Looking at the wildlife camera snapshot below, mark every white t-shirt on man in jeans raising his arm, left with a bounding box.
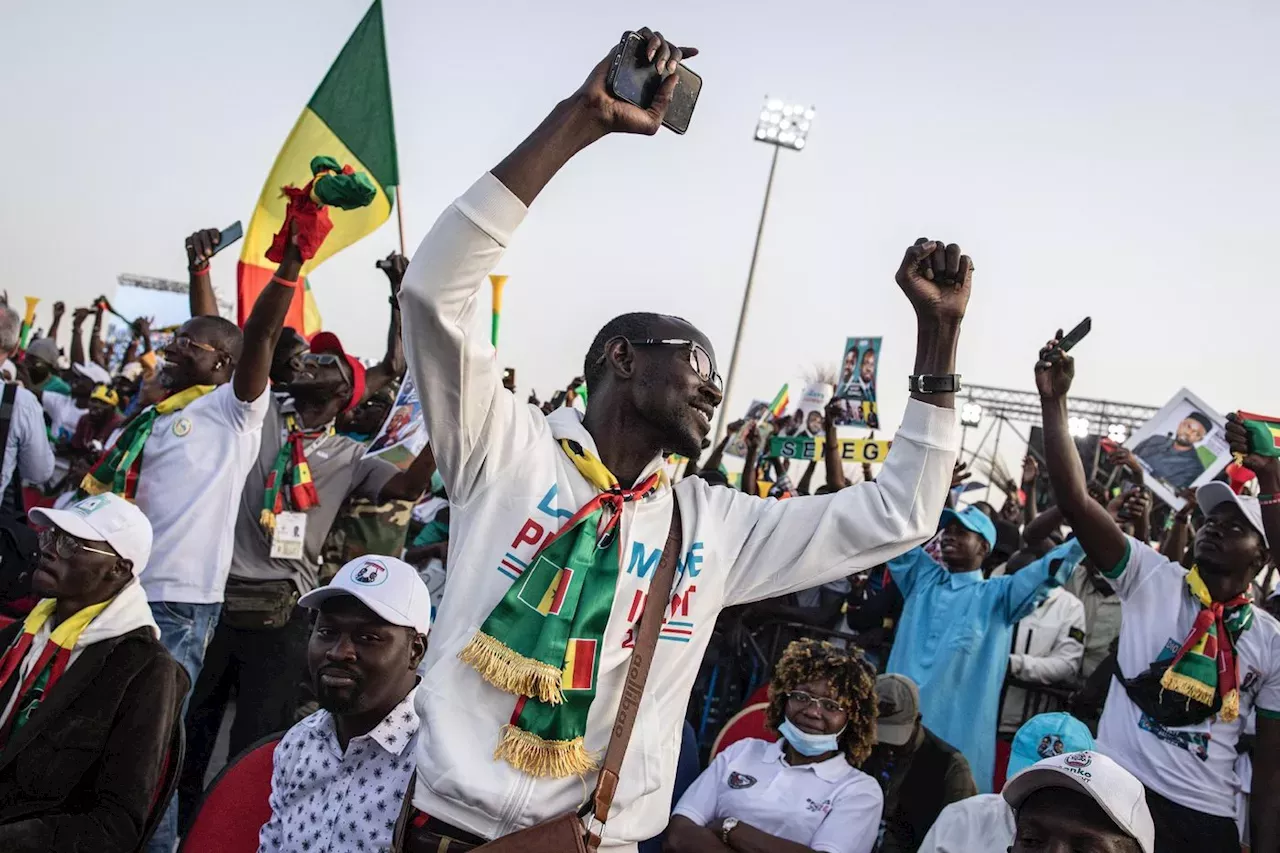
[137,383,271,605]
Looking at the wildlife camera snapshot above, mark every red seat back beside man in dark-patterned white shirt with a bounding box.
[178,733,284,853]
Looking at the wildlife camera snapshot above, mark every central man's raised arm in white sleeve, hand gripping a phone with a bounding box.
[399,33,696,502]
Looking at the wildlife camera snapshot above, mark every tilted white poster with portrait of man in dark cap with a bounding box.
[1125,388,1231,510]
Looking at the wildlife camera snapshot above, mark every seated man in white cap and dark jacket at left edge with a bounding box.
[0,494,187,853]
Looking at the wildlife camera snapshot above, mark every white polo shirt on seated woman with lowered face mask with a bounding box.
[672,738,884,853]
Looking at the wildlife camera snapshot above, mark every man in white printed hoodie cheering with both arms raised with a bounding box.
[399,29,972,849]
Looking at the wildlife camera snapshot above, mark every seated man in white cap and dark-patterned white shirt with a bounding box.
[259,555,431,853]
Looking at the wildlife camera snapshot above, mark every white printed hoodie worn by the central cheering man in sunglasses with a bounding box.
[399,174,959,850]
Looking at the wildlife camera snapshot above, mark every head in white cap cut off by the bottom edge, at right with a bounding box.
[1004,751,1156,853]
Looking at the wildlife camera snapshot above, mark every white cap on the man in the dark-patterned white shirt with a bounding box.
[298,553,431,637]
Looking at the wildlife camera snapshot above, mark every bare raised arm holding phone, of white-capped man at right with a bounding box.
[1024,330,1129,573]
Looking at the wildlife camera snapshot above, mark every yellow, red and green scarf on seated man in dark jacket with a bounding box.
[0,598,111,748]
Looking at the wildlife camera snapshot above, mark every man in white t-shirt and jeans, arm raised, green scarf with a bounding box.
[81,224,302,853]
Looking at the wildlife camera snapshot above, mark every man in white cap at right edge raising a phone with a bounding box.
[1036,341,1280,853]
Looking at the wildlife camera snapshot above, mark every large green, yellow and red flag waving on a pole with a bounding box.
[237,0,399,338]
